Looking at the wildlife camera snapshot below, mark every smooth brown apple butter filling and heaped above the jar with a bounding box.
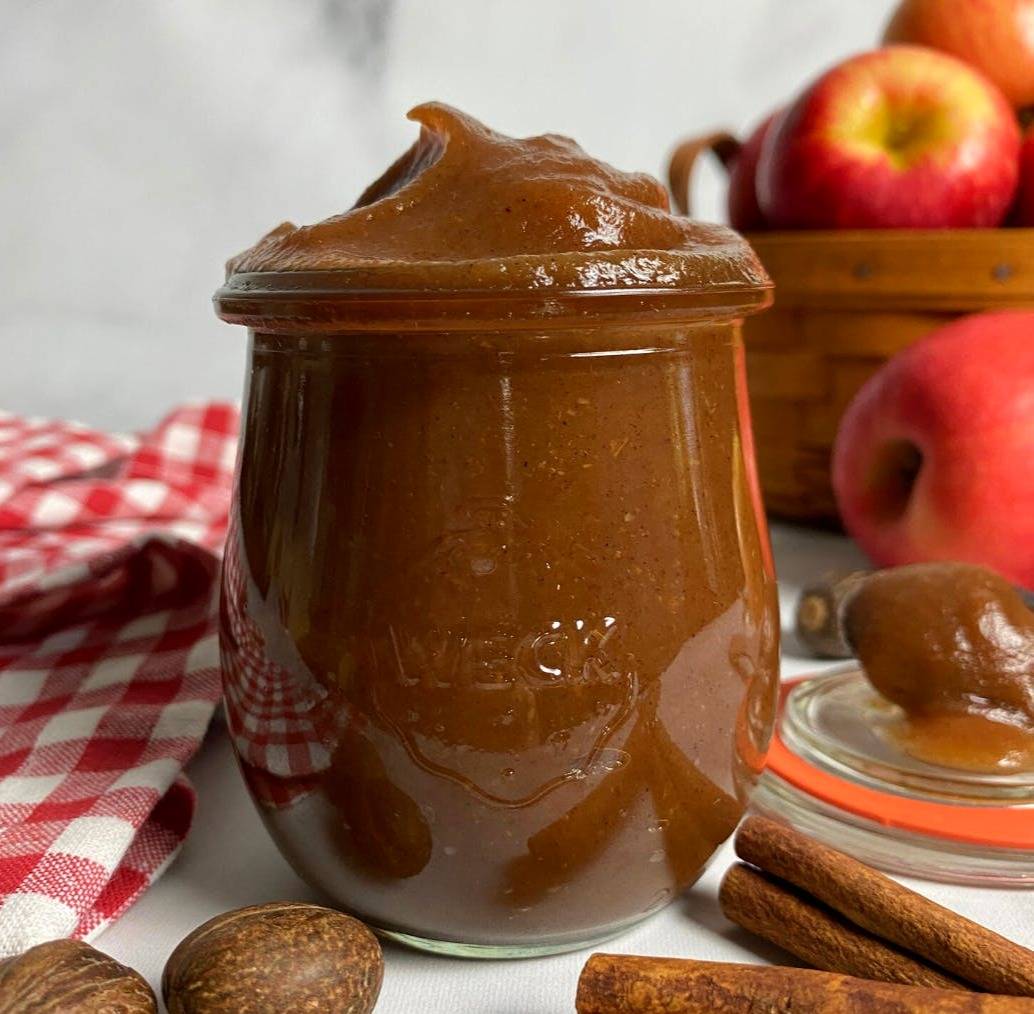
[222,98,778,945]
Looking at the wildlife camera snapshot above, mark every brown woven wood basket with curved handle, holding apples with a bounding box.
[670,134,1034,527]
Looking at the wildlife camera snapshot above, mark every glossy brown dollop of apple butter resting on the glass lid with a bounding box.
[846,563,1034,771]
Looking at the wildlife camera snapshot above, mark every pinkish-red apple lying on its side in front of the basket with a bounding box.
[832,310,1034,588]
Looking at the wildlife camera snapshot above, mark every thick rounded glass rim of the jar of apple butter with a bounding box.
[212,270,773,333]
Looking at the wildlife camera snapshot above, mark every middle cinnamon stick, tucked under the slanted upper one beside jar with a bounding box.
[718,863,968,990]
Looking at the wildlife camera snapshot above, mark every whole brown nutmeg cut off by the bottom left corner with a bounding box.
[0,940,158,1014]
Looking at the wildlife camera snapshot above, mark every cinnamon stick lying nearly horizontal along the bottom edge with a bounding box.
[575,954,1034,1014]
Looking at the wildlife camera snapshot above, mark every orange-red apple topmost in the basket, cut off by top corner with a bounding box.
[883,0,1034,106]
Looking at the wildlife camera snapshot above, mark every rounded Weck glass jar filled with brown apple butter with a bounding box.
[216,272,779,956]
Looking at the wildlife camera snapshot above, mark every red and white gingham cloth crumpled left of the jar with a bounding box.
[0,404,238,957]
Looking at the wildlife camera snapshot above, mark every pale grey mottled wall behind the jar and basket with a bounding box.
[0,0,893,428]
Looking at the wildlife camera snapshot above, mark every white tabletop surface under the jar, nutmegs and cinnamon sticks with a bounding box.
[96,526,1034,1014]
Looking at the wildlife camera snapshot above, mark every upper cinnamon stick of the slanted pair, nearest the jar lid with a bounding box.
[736,817,1034,996]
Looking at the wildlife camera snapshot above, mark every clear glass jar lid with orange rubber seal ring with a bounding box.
[754,678,1034,886]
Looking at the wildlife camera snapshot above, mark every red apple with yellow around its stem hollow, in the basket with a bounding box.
[758,45,1020,228]
